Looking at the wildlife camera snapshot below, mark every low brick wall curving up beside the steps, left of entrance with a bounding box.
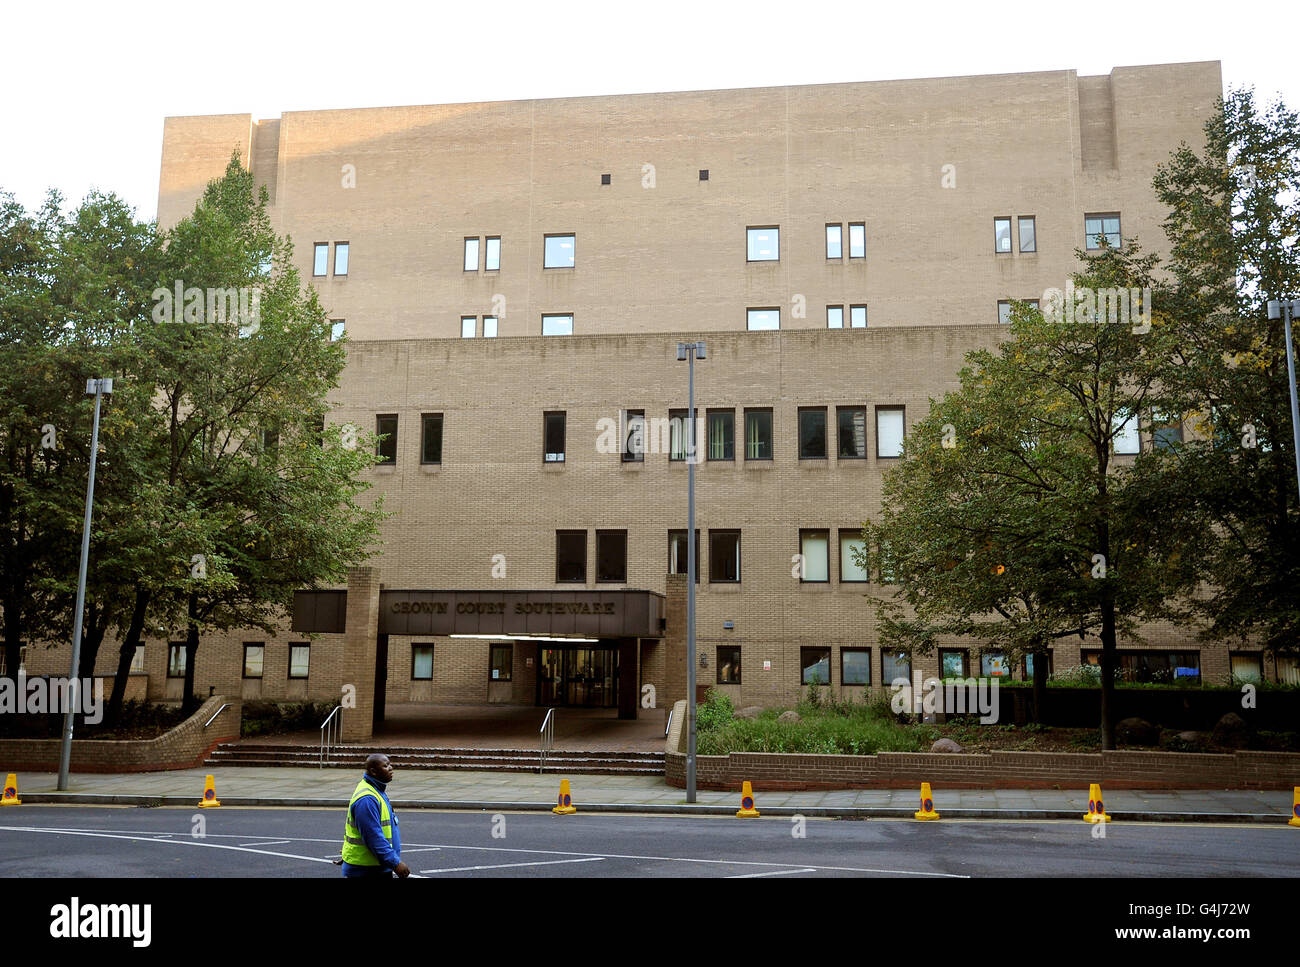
[0,695,243,772]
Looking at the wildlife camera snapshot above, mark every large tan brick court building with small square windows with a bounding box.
[42,62,1296,738]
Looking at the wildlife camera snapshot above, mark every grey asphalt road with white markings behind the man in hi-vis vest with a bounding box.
[0,806,1300,880]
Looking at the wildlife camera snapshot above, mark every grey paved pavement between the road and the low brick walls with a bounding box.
[4,766,1300,834]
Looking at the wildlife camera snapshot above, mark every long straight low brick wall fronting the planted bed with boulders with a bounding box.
[666,750,1300,792]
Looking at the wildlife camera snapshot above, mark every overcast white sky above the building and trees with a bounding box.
[0,0,1300,218]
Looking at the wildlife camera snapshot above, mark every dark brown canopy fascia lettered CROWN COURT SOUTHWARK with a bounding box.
[293,590,664,638]
